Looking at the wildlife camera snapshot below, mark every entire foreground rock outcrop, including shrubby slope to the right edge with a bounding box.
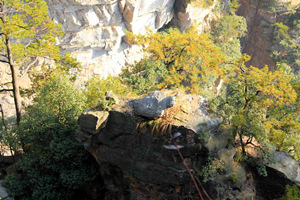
[78,91,300,200]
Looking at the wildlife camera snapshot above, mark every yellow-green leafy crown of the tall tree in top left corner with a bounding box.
[0,0,63,66]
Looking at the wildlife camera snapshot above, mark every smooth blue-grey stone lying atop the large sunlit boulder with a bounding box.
[133,91,175,119]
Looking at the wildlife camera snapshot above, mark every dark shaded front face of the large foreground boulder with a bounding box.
[79,111,213,200]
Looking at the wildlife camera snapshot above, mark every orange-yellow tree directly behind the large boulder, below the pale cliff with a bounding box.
[127,28,226,93]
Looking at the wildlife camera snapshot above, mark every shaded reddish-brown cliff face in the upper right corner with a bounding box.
[237,0,300,70]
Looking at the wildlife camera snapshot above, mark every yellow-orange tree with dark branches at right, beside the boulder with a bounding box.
[210,56,300,173]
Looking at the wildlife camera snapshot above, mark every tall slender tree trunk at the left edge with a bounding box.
[5,35,22,125]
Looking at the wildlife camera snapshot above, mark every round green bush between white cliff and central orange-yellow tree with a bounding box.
[122,60,169,94]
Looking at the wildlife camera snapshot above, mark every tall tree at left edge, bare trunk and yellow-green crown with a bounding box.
[0,0,62,124]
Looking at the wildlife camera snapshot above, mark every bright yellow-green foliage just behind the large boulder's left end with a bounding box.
[84,76,130,109]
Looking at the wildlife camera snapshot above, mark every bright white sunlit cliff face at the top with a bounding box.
[47,0,213,77]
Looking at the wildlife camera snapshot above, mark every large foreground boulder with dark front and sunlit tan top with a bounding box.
[78,91,244,200]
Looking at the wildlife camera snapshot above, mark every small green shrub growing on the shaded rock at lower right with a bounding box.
[201,158,225,183]
